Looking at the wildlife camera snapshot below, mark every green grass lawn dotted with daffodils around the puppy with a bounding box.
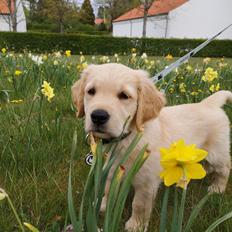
[0,51,232,232]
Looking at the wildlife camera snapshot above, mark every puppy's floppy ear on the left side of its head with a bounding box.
[71,65,92,118]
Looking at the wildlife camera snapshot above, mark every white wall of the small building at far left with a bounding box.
[0,0,27,32]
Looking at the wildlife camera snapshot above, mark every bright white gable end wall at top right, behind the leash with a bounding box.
[167,0,232,39]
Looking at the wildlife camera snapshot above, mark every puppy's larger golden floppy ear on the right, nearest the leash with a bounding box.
[135,70,166,130]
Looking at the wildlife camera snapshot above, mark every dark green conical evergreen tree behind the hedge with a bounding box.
[80,0,95,25]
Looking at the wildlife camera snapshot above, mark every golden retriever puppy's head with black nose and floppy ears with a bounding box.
[72,64,165,138]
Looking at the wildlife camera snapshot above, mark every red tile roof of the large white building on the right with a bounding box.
[114,0,188,22]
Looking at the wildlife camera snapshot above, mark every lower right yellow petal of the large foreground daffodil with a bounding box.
[185,163,206,179]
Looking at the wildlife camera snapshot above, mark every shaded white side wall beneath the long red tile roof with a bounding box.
[113,16,166,38]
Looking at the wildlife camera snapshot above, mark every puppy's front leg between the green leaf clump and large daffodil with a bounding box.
[125,178,160,232]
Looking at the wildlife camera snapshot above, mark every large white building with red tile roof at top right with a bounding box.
[113,0,232,39]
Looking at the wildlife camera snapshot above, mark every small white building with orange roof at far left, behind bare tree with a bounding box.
[0,0,27,32]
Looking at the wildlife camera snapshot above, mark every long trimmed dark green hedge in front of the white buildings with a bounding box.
[0,32,232,57]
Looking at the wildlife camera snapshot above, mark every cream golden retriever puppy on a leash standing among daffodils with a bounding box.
[72,64,232,231]
